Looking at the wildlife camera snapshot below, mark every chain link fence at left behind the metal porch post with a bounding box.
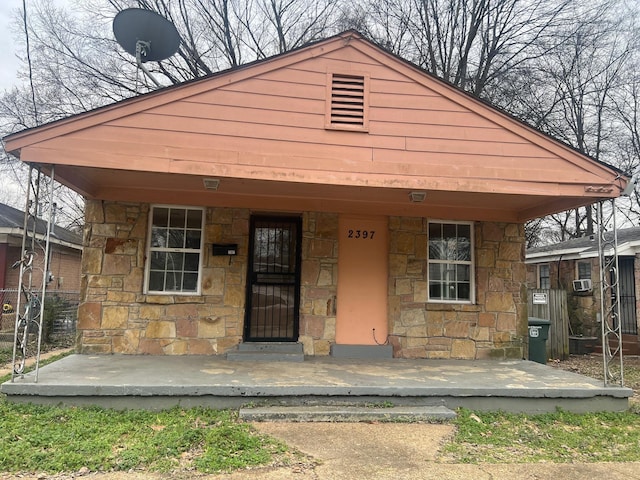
[0,290,80,351]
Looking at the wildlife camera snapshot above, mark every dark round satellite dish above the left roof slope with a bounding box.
[113,8,180,87]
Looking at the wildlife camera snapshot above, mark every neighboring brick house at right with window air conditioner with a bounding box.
[526,227,640,343]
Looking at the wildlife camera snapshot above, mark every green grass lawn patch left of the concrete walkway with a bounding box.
[0,401,292,473]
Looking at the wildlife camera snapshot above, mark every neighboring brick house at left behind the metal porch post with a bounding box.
[0,203,82,291]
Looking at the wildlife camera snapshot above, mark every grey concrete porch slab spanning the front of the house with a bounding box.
[0,355,633,413]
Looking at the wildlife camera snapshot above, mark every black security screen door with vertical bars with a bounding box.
[244,217,301,342]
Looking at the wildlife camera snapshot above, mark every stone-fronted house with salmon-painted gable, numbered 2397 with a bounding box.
[5,32,628,359]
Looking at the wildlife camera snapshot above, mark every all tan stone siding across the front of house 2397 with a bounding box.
[77,200,527,359]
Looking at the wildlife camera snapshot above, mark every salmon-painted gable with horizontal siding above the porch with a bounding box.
[5,32,628,221]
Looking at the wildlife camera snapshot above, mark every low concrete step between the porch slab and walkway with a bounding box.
[239,405,456,422]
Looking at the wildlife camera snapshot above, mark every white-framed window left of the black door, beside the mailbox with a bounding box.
[145,205,204,294]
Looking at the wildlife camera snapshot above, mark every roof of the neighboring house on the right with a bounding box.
[526,227,640,263]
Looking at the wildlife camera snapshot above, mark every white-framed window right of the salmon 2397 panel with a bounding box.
[427,222,475,303]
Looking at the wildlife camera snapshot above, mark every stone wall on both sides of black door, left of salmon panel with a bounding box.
[77,200,338,355]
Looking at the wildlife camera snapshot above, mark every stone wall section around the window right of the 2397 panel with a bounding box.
[389,217,527,359]
